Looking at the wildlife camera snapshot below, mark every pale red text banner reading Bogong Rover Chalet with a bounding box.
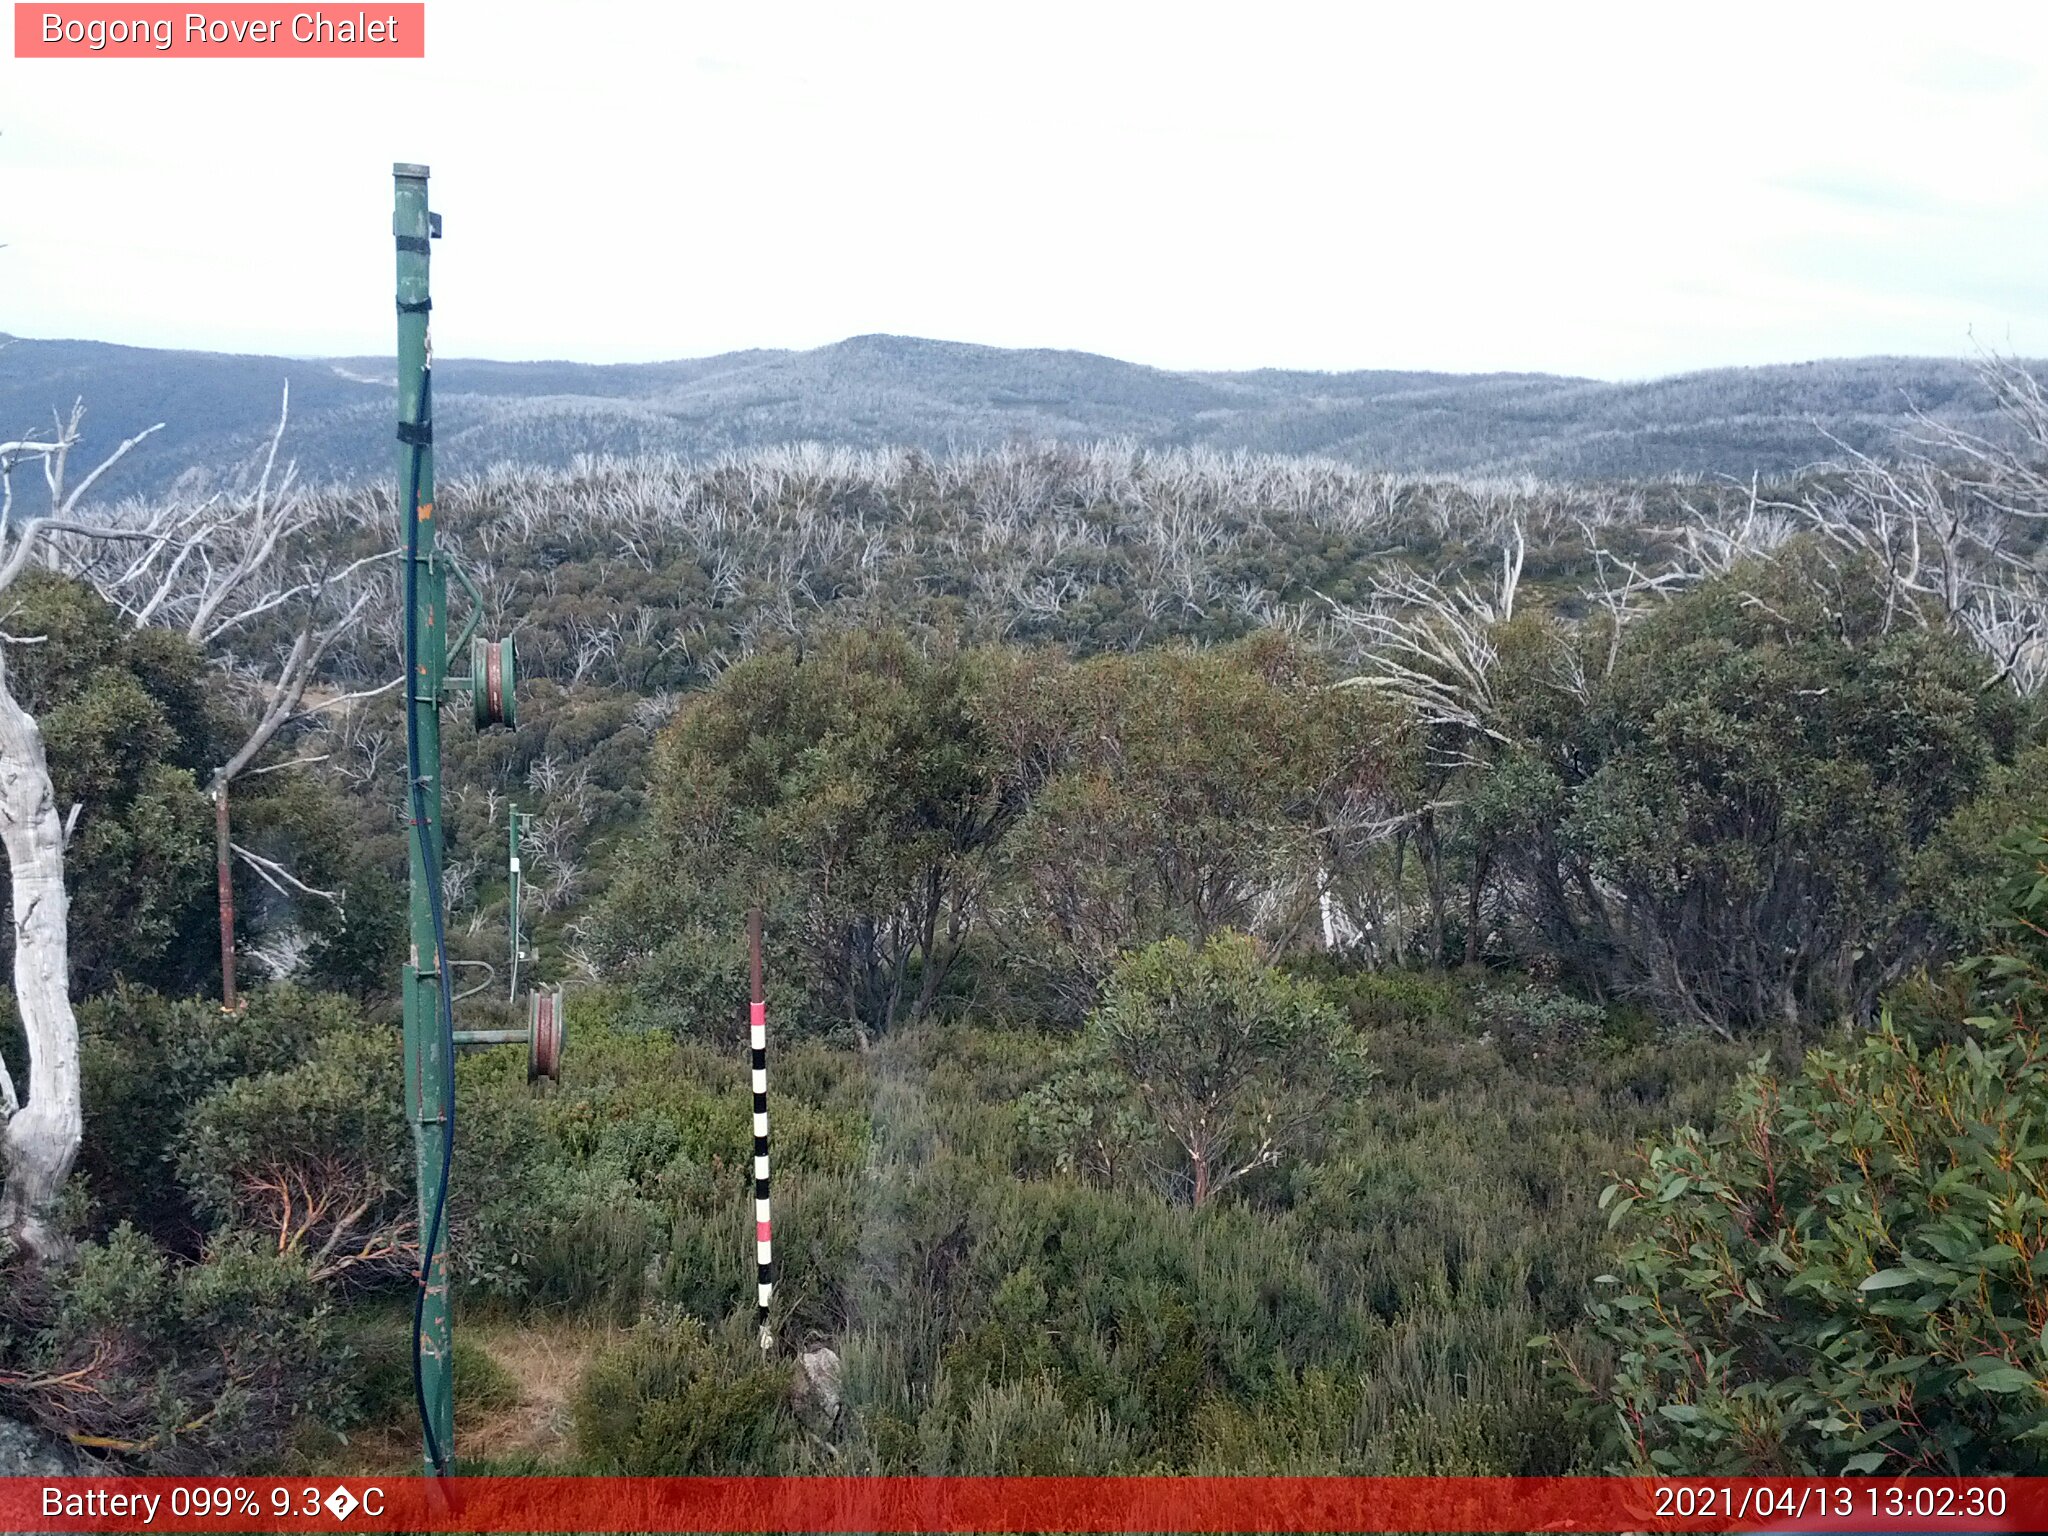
[14,0,426,59]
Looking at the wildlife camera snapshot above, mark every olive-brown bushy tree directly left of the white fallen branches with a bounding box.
[1001,629,1407,1022]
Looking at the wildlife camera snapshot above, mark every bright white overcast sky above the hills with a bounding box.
[0,0,2048,379]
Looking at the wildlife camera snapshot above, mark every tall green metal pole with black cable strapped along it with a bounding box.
[391,164,455,1473]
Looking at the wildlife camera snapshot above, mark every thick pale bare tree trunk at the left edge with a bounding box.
[0,657,84,1257]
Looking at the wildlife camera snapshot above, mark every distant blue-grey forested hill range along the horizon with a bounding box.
[0,336,2015,492]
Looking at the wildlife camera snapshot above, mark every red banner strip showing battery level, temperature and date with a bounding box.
[0,1477,2048,1532]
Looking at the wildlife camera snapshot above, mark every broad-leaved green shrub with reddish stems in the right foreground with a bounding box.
[1567,842,2048,1475]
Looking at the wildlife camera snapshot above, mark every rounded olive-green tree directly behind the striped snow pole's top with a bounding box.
[592,629,1051,1038]
